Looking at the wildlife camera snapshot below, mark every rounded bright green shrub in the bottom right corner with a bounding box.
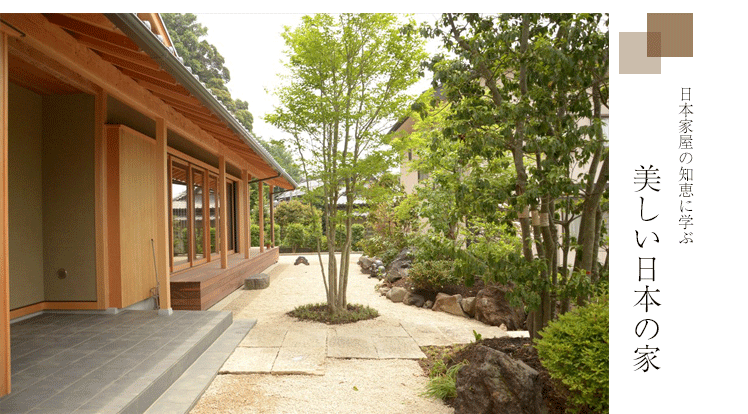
[535,296,609,413]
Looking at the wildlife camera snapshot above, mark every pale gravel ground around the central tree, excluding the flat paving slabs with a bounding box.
[191,255,496,414]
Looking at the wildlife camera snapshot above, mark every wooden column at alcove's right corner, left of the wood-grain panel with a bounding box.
[94,90,109,309]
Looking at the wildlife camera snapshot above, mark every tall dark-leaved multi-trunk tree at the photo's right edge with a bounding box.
[422,14,609,335]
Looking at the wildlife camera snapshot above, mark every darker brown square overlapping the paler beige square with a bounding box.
[647,13,693,57]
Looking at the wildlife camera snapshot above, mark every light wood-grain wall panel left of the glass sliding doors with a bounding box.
[119,126,159,307]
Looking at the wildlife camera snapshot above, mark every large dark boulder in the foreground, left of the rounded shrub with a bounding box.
[454,345,543,414]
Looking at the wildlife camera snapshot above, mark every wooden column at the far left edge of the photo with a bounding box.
[0,32,10,395]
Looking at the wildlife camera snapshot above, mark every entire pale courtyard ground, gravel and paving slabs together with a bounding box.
[192,255,527,414]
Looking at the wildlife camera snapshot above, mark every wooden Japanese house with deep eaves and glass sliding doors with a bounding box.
[0,13,296,396]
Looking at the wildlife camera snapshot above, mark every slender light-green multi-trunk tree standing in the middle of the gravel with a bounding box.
[267,14,425,312]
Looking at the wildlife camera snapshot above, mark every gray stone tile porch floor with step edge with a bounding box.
[0,310,231,413]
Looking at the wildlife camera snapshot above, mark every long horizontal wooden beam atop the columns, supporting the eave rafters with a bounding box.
[3,14,251,183]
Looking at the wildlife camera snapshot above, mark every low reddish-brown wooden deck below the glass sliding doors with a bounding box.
[171,247,278,310]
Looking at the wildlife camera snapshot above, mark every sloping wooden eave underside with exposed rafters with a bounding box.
[2,13,293,189]
